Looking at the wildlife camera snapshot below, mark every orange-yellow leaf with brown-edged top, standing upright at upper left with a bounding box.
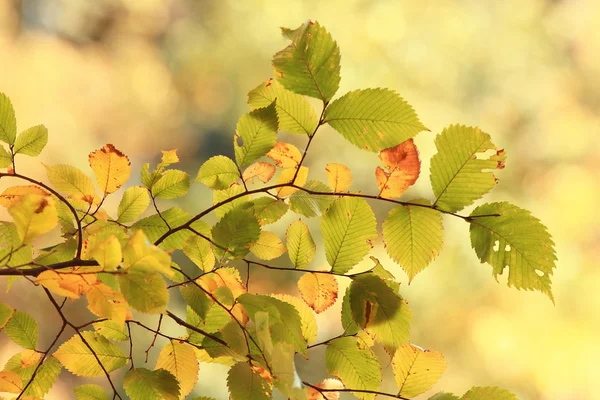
[88,144,131,195]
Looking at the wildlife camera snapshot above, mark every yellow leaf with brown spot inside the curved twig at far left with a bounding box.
[8,194,58,243]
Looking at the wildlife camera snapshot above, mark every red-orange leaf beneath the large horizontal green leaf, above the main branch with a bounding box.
[375,139,421,199]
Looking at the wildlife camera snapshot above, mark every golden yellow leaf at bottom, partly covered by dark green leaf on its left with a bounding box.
[154,340,199,399]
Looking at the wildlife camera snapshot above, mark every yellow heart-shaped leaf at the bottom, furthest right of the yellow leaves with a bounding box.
[392,343,446,397]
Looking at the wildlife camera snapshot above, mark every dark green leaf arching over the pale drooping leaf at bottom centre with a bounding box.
[238,293,306,356]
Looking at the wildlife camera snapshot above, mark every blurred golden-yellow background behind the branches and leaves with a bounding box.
[0,0,600,400]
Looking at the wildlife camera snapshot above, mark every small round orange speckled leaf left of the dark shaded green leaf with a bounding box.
[298,272,338,314]
